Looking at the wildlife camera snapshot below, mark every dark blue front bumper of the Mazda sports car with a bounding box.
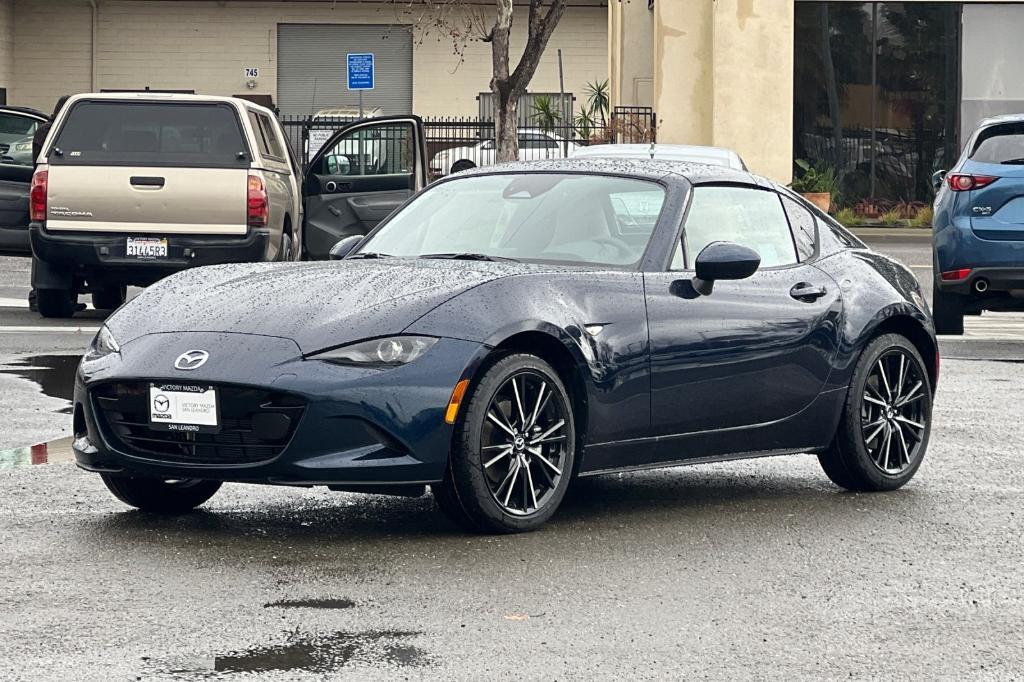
[73,333,486,485]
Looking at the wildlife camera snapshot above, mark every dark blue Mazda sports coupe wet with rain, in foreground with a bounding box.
[74,159,939,531]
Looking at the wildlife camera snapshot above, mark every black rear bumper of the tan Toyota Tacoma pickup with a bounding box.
[29,222,270,287]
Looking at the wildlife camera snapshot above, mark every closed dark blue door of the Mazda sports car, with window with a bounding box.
[645,185,842,461]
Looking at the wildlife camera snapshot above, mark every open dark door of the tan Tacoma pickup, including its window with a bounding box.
[303,116,427,258]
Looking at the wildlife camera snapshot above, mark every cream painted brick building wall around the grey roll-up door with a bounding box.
[8,0,607,116]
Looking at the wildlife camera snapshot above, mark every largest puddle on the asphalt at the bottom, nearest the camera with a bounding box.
[209,631,428,674]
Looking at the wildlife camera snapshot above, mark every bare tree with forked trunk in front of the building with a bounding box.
[392,0,566,161]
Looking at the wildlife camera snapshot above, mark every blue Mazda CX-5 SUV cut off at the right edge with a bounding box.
[932,114,1024,335]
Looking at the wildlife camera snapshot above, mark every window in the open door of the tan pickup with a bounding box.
[321,123,415,176]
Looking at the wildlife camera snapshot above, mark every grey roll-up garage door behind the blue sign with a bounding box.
[278,24,413,116]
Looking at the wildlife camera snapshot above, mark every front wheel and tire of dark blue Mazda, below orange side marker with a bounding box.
[432,353,577,532]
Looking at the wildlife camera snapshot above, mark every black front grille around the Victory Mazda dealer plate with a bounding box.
[91,381,305,464]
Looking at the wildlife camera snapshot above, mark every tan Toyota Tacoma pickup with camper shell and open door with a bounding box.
[31,93,425,317]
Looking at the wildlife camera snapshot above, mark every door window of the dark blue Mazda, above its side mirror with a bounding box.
[683,185,797,267]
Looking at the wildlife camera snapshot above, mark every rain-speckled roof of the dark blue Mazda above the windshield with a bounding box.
[455,157,761,187]
